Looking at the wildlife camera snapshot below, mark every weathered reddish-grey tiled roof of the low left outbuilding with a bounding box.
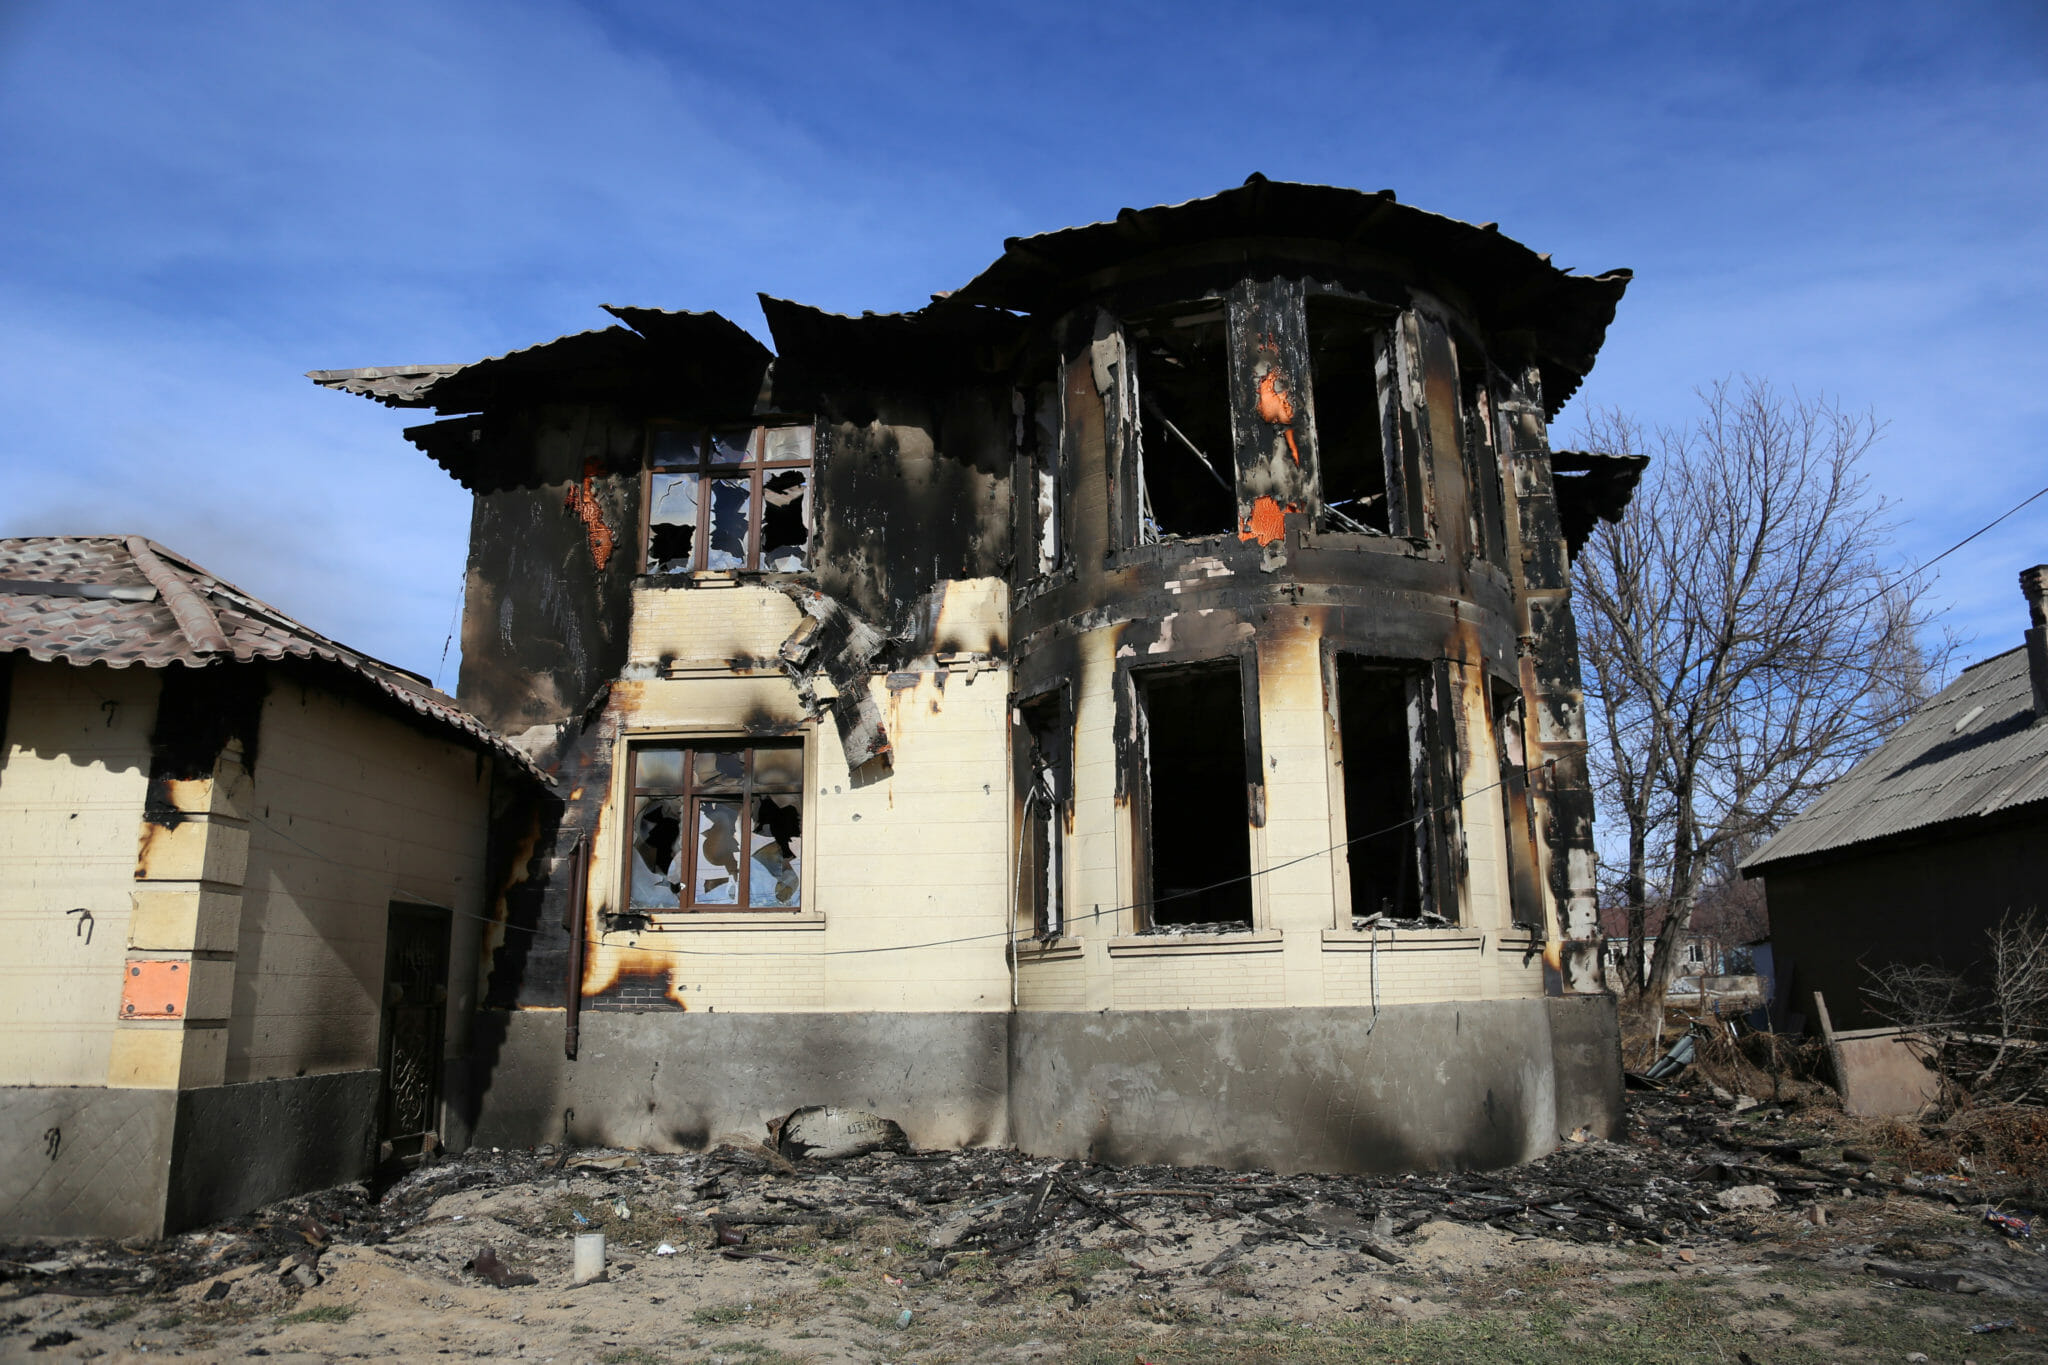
[0,536,547,782]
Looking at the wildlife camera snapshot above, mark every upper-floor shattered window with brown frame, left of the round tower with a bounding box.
[647,426,811,573]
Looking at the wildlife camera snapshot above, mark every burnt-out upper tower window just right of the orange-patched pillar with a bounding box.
[1305,295,1395,536]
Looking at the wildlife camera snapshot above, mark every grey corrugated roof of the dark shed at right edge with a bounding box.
[1743,649,2048,876]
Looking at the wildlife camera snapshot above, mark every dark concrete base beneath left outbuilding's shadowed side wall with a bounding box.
[164,1070,383,1232]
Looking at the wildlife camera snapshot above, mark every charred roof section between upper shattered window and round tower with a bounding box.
[760,295,1030,411]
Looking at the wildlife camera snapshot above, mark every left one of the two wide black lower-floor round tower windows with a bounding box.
[1139,661,1251,929]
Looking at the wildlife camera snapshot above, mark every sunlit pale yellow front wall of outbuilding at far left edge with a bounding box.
[0,659,160,1085]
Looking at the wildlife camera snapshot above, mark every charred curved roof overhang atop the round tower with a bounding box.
[950,174,1632,417]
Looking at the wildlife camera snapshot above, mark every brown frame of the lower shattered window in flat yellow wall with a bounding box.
[618,733,811,919]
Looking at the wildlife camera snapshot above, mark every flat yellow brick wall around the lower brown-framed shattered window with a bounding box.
[584,642,1014,1011]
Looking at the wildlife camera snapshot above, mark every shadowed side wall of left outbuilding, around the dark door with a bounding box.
[225,671,489,1083]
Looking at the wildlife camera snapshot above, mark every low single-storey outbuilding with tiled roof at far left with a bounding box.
[0,536,535,1236]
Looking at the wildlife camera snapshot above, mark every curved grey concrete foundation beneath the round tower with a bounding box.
[1010,1001,1620,1171]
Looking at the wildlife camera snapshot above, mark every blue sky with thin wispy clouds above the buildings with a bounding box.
[0,0,2048,686]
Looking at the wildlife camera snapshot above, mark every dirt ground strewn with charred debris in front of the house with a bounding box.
[0,1095,2048,1365]
